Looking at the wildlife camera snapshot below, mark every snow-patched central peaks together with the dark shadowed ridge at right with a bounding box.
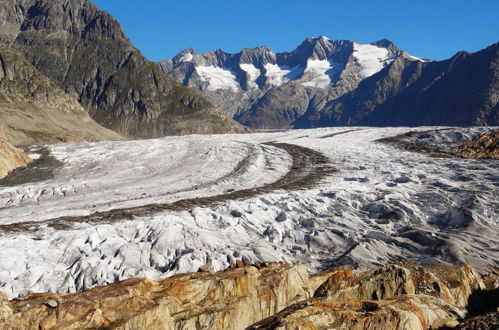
[159,36,499,128]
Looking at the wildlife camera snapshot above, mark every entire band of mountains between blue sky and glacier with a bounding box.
[0,0,499,145]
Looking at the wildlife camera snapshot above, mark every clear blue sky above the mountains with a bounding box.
[93,0,499,61]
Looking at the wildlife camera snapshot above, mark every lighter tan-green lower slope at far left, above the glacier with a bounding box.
[0,43,122,145]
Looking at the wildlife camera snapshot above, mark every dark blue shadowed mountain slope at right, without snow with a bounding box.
[296,43,499,127]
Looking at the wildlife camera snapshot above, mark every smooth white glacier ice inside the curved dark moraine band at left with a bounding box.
[0,135,291,225]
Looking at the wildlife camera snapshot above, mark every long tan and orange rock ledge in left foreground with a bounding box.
[0,264,311,329]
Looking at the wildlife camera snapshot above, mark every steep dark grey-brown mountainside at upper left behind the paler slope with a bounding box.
[0,0,242,137]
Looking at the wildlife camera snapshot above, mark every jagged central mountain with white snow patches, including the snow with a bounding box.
[159,36,403,128]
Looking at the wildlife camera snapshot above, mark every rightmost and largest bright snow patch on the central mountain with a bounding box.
[353,42,394,78]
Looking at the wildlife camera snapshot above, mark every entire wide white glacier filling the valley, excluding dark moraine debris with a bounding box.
[0,127,499,297]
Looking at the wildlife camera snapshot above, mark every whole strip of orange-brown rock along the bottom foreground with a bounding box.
[0,262,497,329]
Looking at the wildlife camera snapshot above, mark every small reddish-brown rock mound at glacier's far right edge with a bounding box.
[456,130,499,159]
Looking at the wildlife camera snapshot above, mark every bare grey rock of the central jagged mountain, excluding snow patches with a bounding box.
[158,37,402,128]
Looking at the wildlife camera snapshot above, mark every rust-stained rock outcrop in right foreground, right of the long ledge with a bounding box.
[250,263,494,329]
